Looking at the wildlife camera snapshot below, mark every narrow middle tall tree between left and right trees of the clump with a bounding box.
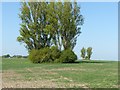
[46,2,62,50]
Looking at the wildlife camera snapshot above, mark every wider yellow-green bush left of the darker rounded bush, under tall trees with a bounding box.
[29,46,60,63]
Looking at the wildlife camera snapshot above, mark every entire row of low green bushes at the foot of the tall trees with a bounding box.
[29,47,77,63]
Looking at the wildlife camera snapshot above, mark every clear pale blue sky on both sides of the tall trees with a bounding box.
[0,2,118,60]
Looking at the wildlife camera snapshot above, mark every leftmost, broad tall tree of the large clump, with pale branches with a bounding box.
[17,2,51,50]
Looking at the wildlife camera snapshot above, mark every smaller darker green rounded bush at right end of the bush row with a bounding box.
[58,49,77,63]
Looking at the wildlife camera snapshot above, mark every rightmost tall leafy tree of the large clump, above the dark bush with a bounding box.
[60,2,84,49]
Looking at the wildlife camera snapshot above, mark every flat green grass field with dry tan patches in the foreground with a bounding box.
[2,59,118,88]
